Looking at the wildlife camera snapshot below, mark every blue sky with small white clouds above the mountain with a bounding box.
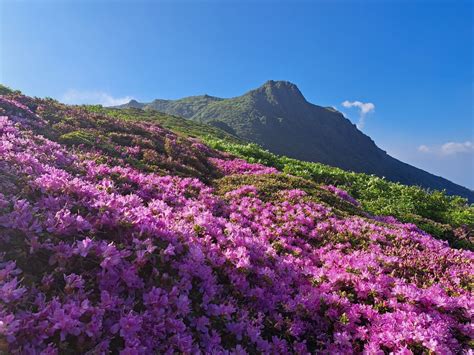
[0,0,474,189]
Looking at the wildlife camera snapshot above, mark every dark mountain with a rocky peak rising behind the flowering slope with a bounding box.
[117,80,474,202]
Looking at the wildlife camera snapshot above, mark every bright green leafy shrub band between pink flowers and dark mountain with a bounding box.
[206,138,474,250]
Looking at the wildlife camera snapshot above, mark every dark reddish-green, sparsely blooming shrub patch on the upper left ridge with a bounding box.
[0,95,219,180]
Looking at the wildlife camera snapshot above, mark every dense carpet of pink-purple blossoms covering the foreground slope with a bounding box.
[0,98,474,354]
